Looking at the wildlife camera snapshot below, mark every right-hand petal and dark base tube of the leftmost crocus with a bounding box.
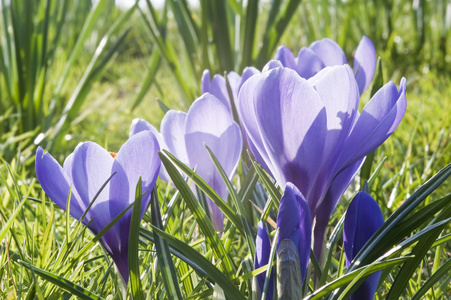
[103,131,161,279]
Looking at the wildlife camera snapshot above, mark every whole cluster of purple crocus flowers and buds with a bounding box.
[36,37,406,299]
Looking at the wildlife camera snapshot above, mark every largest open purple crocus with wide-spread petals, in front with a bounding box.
[237,61,406,258]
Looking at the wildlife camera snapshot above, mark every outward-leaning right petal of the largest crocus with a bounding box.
[337,78,407,168]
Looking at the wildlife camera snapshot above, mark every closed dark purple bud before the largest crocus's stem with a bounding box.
[277,182,312,282]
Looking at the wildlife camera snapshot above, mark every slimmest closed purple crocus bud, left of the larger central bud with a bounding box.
[254,221,274,299]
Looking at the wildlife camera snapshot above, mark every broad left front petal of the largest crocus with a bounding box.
[252,68,327,192]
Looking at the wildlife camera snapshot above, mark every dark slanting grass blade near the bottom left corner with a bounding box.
[19,261,103,300]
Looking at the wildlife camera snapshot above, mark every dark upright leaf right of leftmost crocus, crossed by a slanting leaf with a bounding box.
[150,189,183,299]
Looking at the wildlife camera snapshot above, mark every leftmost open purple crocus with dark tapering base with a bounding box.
[36,132,161,282]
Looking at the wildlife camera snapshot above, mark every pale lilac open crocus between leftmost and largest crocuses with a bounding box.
[130,93,243,230]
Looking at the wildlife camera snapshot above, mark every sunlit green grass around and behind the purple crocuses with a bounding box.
[0,0,451,299]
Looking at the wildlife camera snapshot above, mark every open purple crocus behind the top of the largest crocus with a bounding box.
[274,36,376,94]
